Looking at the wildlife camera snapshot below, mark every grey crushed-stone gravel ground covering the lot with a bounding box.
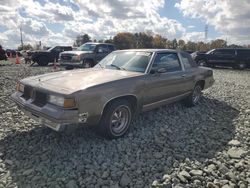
[0,64,250,188]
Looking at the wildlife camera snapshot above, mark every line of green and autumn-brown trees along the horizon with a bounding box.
[18,32,250,52]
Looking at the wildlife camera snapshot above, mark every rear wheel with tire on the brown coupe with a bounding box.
[184,83,202,107]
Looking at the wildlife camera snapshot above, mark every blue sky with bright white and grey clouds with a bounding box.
[0,0,250,48]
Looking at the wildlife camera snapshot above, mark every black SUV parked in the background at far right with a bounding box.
[193,48,250,69]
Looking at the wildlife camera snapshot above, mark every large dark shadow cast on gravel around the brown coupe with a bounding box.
[0,97,239,187]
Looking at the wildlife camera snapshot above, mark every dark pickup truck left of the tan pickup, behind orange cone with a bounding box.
[31,46,72,66]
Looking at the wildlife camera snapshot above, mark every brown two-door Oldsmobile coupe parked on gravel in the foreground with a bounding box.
[12,49,214,138]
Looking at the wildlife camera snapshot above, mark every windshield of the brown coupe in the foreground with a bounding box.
[96,51,152,73]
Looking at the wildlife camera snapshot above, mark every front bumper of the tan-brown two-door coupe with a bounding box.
[11,92,86,131]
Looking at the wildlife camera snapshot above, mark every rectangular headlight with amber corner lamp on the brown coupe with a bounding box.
[48,95,76,108]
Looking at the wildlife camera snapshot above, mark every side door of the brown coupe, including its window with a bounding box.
[144,52,185,105]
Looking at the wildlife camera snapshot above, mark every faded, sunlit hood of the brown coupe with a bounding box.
[21,68,143,94]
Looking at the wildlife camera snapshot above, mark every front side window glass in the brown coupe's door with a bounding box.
[152,52,182,72]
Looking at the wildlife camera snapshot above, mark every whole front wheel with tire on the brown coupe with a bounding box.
[97,100,132,139]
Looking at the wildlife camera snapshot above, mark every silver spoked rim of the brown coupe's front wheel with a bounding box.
[110,106,130,134]
